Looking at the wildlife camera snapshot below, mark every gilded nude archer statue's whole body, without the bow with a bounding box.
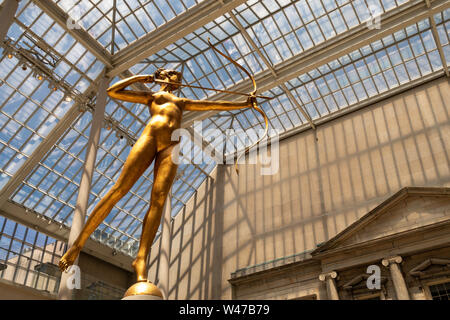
[59,69,255,282]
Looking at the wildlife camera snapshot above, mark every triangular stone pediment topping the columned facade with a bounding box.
[312,188,450,255]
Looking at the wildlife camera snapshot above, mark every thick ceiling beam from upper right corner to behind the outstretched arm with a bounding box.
[179,0,450,126]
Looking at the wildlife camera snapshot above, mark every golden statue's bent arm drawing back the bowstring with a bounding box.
[108,75,154,105]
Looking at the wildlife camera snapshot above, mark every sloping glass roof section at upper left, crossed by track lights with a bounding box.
[0,1,102,187]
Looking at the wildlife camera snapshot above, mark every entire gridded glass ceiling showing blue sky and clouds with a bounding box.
[0,0,450,256]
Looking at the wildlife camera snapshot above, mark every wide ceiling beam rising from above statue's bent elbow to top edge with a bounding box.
[108,0,250,78]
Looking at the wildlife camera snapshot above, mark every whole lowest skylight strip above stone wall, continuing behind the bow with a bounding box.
[204,11,449,158]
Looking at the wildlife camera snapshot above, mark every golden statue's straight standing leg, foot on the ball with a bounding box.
[133,146,178,282]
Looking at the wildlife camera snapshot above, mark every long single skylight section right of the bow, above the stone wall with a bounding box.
[278,16,442,125]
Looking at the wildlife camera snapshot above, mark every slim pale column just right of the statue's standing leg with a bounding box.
[158,194,172,300]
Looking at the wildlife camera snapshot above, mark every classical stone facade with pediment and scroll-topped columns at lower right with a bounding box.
[230,188,450,300]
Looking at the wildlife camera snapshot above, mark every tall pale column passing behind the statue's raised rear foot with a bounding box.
[58,77,110,300]
